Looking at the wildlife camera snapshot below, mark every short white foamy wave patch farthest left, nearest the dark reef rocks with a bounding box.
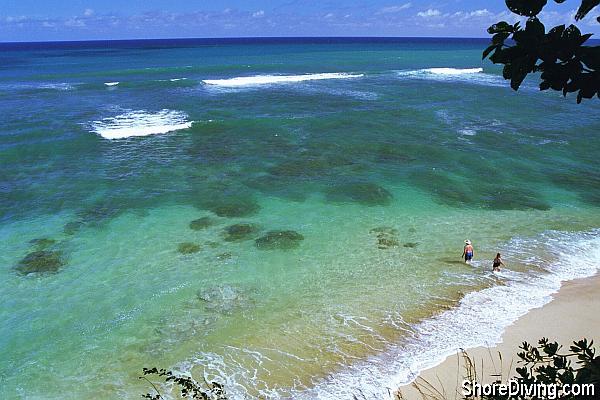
[90,109,192,139]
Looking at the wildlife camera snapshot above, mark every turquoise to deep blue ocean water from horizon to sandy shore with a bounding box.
[0,39,600,399]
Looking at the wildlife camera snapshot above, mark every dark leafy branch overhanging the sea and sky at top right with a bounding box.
[483,0,600,103]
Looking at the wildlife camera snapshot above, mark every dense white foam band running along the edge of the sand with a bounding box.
[293,230,600,400]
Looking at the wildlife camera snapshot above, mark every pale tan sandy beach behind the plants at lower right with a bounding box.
[400,275,600,400]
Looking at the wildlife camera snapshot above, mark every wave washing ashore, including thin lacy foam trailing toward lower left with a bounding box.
[166,229,600,400]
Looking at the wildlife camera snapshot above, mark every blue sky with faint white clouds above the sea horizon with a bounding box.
[0,0,600,42]
